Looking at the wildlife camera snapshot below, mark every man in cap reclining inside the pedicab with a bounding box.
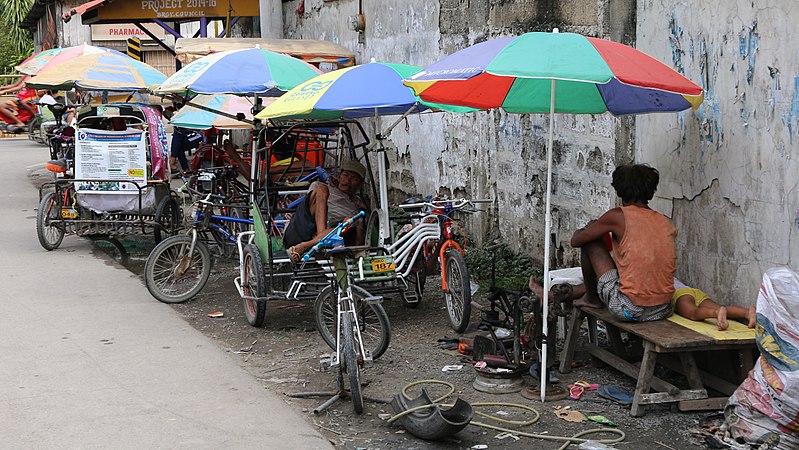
[283,160,366,263]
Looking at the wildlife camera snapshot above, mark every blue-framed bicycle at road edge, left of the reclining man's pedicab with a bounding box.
[144,194,253,303]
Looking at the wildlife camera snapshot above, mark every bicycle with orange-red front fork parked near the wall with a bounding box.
[388,198,493,333]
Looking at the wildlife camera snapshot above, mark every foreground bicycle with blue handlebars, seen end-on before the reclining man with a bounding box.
[303,211,391,414]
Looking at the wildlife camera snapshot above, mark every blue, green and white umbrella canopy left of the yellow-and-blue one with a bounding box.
[154,48,321,97]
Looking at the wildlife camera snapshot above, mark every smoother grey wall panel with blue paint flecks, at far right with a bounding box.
[635,0,799,305]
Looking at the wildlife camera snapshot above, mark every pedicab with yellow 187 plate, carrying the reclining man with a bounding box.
[235,121,401,358]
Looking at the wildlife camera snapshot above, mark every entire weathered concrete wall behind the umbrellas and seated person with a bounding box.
[283,0,799,305]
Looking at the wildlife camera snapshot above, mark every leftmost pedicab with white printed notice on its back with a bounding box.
[36,103,182,250]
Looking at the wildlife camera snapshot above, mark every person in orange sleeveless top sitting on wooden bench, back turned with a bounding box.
[571,164,677,322]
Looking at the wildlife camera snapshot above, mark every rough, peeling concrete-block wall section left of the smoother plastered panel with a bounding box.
[283,0,636,270]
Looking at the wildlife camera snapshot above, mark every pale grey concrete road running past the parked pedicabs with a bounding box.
[0,139,331,449]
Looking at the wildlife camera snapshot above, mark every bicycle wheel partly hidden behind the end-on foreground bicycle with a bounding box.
[314,286,391,359]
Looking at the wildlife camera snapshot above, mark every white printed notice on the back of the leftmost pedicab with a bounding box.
[75,129,147,193]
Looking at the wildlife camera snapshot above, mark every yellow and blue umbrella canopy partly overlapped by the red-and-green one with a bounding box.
[255,62,456,120]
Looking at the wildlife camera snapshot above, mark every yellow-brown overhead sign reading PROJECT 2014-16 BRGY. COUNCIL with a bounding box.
[88,0,259,24]
